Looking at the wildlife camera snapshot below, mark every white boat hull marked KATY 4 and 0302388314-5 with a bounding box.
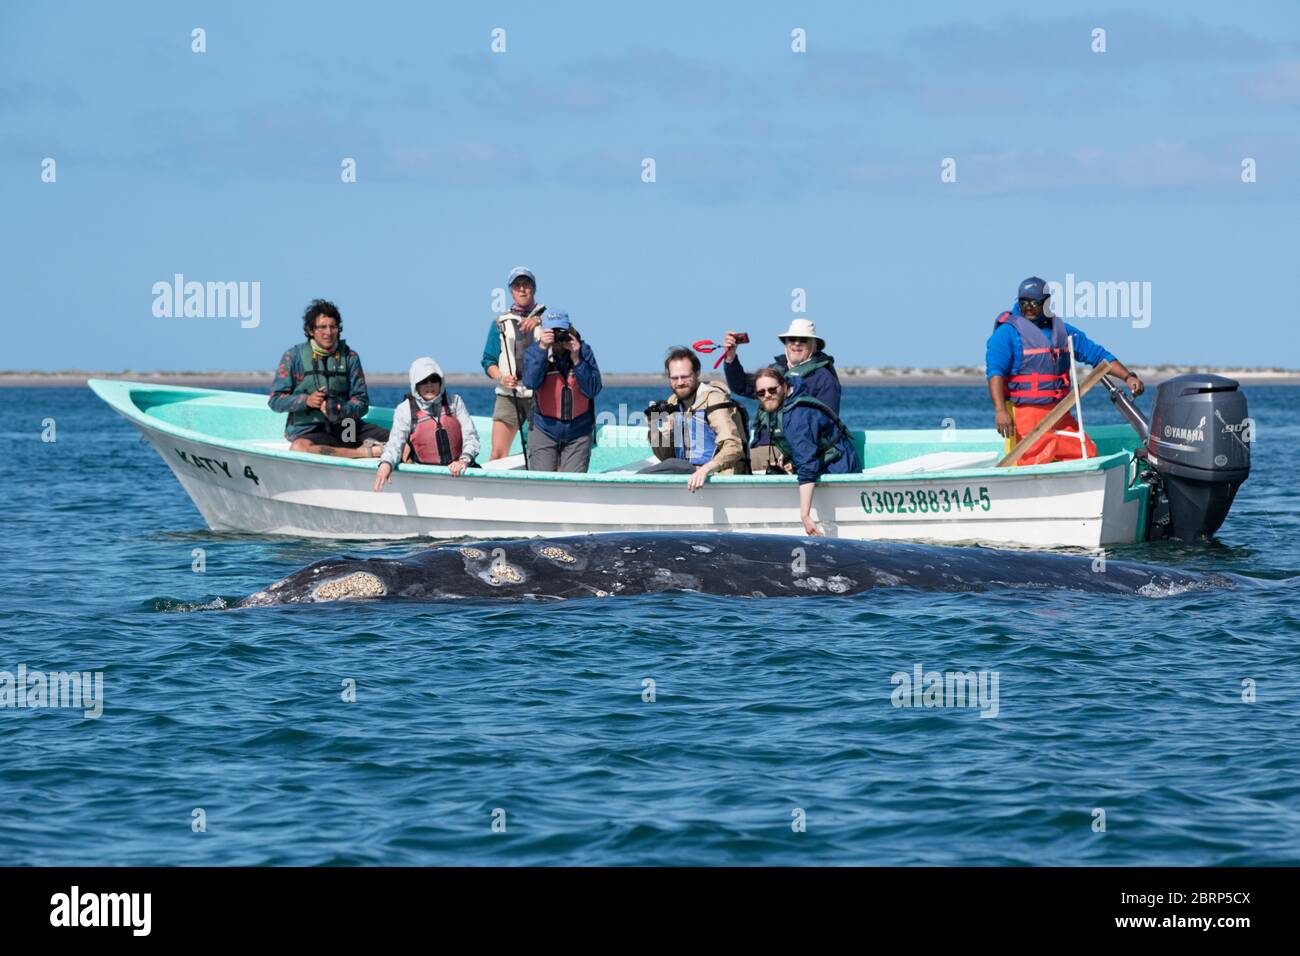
[94,382,1143,549]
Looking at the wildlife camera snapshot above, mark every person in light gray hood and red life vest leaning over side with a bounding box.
[374,356,478,492]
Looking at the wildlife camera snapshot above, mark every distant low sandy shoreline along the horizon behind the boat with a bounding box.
[0,365,1300,389]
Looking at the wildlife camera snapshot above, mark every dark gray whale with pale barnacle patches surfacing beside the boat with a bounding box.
[235,532,1240,607]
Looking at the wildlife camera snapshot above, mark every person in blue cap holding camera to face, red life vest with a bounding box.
[523,310,602,472]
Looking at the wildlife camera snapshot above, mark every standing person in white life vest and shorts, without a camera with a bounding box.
[482,265,546,460]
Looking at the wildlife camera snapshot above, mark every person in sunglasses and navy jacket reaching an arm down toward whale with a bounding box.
[754,368,862,535]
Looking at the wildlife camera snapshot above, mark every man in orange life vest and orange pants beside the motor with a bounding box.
[984,276,1144,464]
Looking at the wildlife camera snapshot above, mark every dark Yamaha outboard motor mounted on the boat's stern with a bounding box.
[1102,373,1255,541]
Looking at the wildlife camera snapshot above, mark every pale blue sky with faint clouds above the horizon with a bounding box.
[0,1,1300,371]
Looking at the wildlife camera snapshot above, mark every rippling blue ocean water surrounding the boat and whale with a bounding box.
[0,386,1300,865]
